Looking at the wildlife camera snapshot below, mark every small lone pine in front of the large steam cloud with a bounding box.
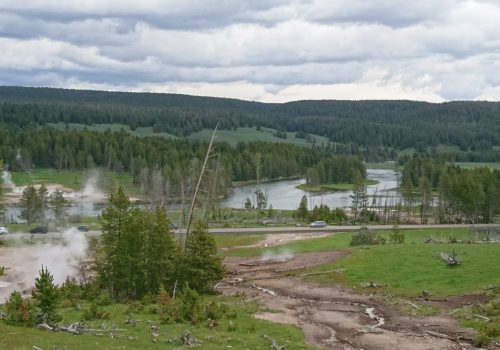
[31,266,62,323]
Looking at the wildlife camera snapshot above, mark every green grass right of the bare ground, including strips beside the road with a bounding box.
[227,229,500,296]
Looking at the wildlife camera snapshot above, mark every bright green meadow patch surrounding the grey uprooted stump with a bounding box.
[311,243,500,296]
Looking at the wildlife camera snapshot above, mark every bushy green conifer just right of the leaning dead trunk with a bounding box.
[178,222,224,293]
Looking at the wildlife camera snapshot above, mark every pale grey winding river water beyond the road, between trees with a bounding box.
[221,169,400,209]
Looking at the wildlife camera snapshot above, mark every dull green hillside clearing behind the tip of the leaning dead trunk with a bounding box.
[188,128,329,147]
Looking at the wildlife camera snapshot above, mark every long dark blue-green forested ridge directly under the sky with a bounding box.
[0,87,500,160]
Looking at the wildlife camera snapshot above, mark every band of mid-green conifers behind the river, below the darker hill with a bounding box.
[0,124,364,186]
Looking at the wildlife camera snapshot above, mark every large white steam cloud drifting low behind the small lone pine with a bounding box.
[0,228,88,304]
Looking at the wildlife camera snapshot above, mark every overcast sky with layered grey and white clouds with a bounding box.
[0,0,500,102]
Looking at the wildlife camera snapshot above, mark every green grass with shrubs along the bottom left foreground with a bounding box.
[0,296,313,350]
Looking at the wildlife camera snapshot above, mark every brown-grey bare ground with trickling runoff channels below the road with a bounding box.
[218,251,495,350]
